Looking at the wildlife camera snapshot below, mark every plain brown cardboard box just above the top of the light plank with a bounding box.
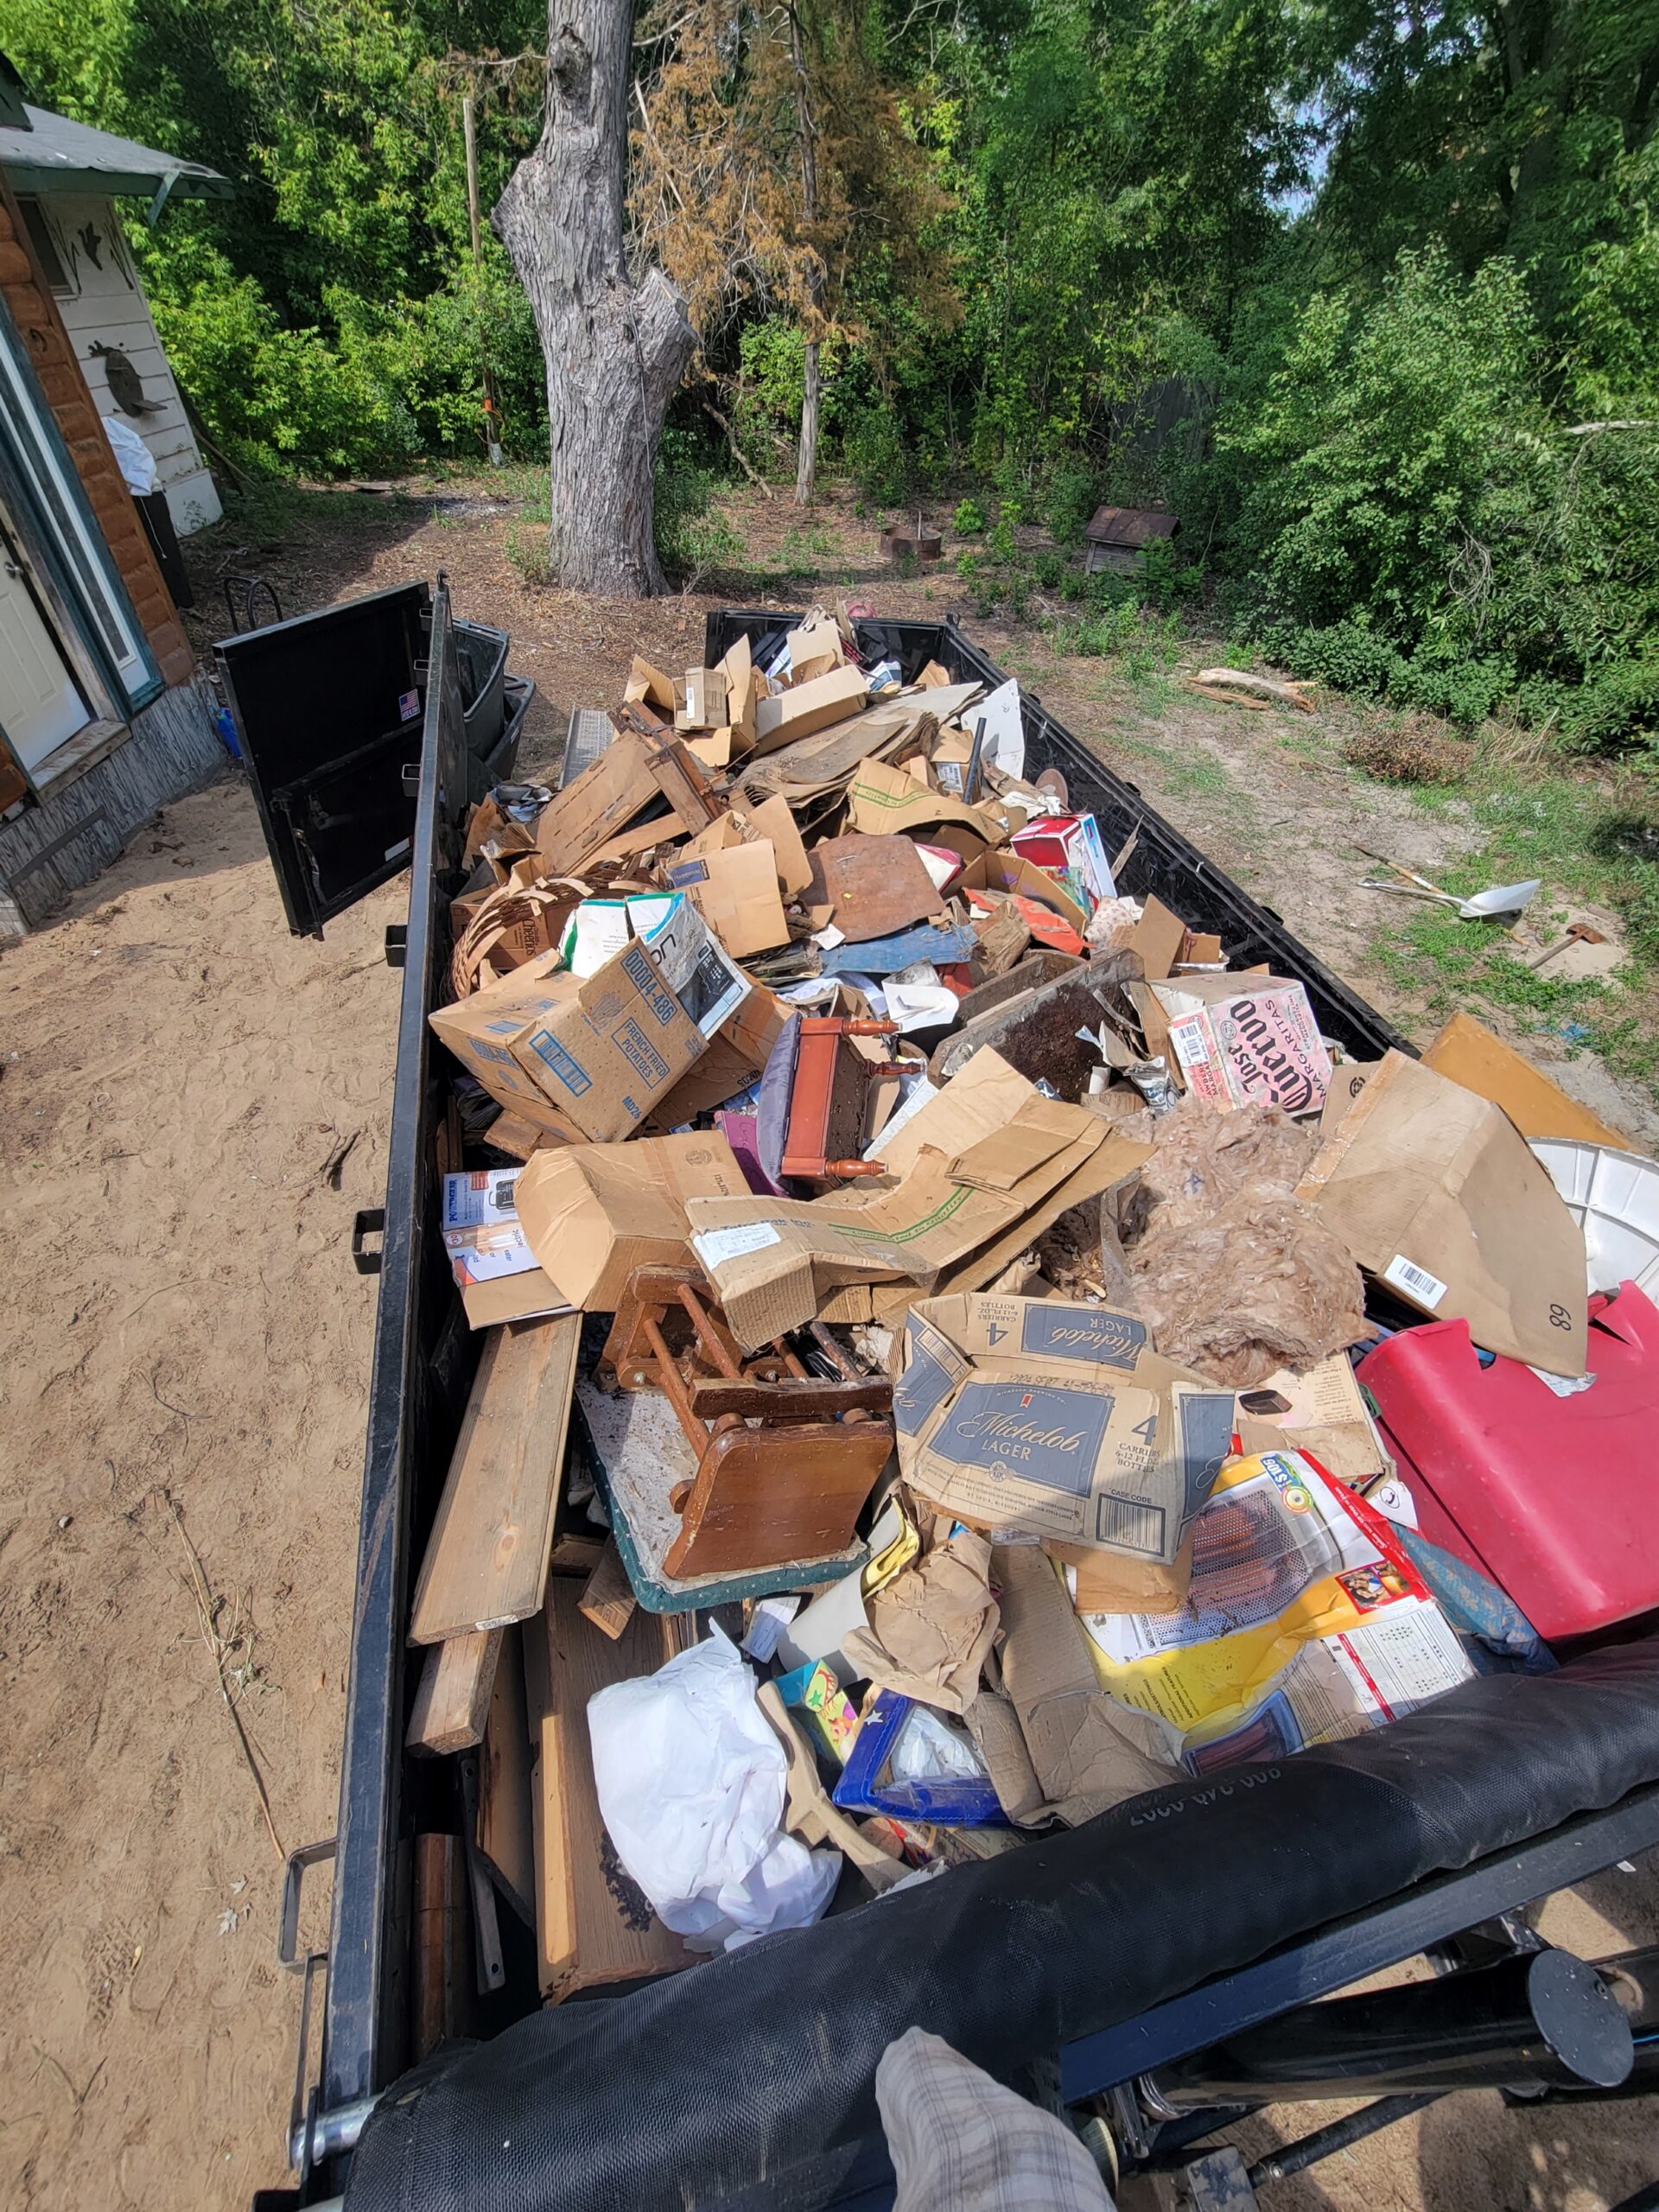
[515,1133,747,1314]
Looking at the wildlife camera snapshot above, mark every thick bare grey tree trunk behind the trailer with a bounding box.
[491,0,696,600]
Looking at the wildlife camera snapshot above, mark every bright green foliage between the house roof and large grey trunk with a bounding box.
[0,0,546,475]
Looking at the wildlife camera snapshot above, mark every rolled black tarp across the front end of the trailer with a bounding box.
[345,1639,1659,2212]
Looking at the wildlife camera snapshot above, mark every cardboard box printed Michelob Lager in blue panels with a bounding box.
[893,1294,1232,1564]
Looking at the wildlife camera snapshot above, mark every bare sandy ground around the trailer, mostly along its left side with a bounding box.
[0,488,1659,2212]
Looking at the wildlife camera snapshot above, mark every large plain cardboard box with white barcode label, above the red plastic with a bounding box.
[1296,1053,1586,1376]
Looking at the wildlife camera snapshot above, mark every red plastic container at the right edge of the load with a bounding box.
[1358,1283,1659,1642]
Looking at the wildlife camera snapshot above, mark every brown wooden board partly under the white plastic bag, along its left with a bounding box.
[524,1580,696,2004]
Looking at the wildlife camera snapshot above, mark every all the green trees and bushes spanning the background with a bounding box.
[0,0,1659,757]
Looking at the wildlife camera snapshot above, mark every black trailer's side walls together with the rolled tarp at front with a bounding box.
[285,588,1659,2212]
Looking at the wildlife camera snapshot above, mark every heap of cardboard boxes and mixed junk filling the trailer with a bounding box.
[393,611,1654,2035]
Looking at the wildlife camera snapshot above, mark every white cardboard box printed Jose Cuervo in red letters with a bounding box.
[1148,976,1332,1113]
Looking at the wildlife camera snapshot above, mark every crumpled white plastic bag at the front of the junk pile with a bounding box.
[588,1628,841,1951]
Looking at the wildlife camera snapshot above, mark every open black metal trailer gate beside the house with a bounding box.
[214,582,429,938]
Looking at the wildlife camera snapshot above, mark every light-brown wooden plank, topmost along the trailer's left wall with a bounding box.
[410,1314,582,1643]
